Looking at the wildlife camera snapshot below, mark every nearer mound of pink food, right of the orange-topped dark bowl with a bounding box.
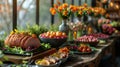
[75,35,98,43]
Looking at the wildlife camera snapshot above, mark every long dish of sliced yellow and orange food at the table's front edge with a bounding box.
[35,48,69,66]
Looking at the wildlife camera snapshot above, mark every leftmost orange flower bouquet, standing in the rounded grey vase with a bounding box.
[50,2,76,19]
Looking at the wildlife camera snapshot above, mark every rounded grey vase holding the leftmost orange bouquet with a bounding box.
[59,19,69,35]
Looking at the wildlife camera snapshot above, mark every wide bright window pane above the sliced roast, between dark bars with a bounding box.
[17,0,36,28]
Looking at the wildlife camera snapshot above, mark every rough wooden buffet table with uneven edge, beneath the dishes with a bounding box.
[0,39,115,67]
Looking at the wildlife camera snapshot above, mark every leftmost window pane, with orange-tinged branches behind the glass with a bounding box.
[0,0,13,34]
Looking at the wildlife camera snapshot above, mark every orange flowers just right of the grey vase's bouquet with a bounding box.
[75,4,106,17]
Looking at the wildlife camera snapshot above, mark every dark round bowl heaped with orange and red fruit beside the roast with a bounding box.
[40,31,67,48]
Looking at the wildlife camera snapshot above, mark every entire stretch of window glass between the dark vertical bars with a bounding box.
[0,0,92,33]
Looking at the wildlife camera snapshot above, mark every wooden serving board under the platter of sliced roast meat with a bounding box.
[3,48,57,64]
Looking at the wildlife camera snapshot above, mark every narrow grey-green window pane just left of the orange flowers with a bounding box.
[39,0,51,25]
